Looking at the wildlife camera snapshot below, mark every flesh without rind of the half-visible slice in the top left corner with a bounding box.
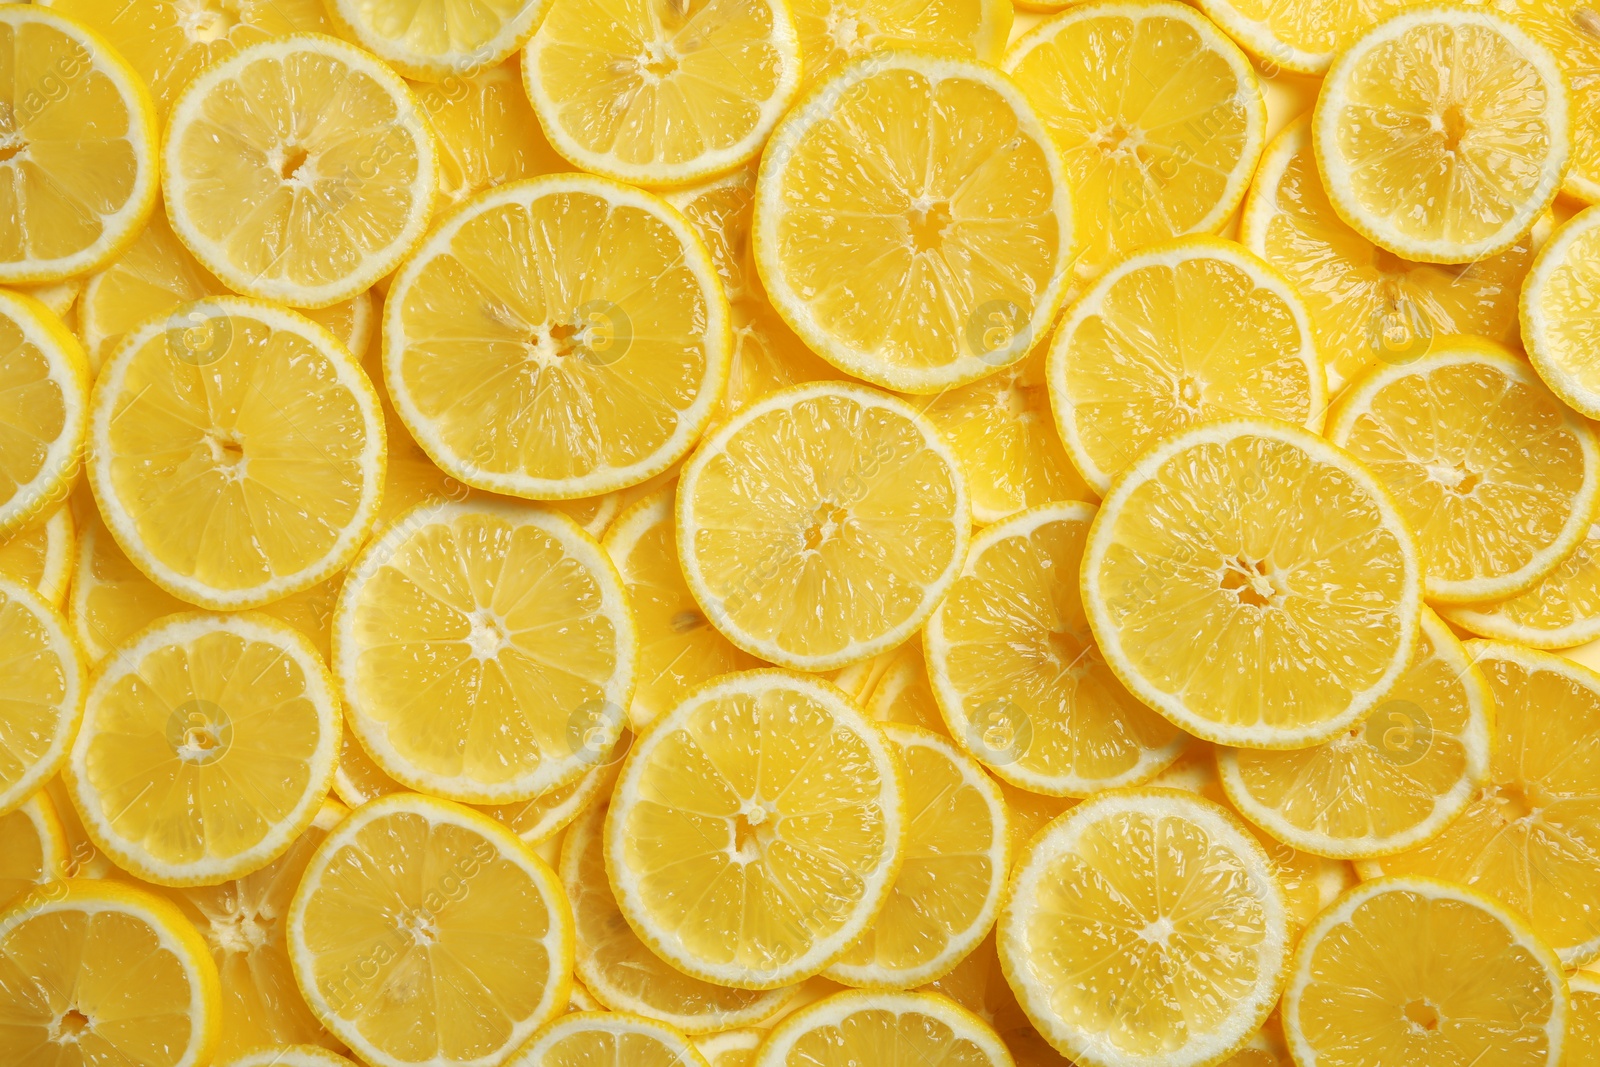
[0,21,144,271]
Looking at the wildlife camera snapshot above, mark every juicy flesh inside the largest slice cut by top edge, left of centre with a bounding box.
[534,0,794,166]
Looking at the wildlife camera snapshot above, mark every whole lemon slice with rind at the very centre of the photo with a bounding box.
[677,382,970,670]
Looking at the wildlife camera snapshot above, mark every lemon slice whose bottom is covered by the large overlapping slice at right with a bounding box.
[1046,237,1328,496]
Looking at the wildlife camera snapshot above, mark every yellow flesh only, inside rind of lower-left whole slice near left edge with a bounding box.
[84,630,328,865]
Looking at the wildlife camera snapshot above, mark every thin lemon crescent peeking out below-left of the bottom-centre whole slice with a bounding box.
[560,803,800,1033]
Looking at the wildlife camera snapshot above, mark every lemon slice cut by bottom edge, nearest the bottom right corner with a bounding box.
[1283,878,1568,1067]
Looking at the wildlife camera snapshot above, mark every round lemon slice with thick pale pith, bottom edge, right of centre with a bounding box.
[997,789,1290,1067]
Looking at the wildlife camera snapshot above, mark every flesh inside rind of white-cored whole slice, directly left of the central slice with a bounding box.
[347,512,622,785]
